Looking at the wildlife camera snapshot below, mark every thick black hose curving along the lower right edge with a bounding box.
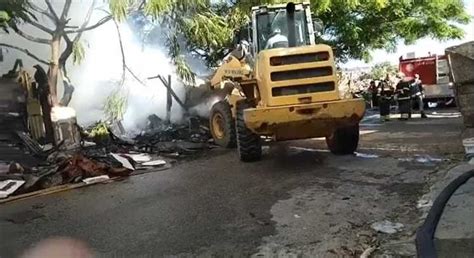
[416,170,474,258]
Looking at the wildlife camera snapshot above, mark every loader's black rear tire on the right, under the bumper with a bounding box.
[326,124,359,155]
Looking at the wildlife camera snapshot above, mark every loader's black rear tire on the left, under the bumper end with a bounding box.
[236,100,262,162]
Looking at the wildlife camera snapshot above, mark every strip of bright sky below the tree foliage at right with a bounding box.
[342,0,474,68]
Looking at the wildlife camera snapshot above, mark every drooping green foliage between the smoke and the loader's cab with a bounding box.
[109,0,247,84]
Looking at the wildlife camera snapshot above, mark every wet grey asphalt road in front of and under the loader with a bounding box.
[0,111,462,257]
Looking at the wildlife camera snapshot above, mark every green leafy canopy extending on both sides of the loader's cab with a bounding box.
[114,0,470,65]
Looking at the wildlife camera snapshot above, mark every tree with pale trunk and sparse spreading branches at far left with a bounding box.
[0,0,112,142]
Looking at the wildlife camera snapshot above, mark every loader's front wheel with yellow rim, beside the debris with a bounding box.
[209,101,237,148]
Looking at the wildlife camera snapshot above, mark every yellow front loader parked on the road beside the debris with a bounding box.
[209,3,365,162]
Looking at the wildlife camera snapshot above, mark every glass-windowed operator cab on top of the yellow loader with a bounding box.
[251,3,321,54]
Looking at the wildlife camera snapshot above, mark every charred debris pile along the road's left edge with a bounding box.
[0,115,212,199]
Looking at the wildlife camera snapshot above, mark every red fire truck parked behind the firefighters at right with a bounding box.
[399,55,454,105]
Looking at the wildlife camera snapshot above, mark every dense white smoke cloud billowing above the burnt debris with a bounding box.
[71,16,185,131]
